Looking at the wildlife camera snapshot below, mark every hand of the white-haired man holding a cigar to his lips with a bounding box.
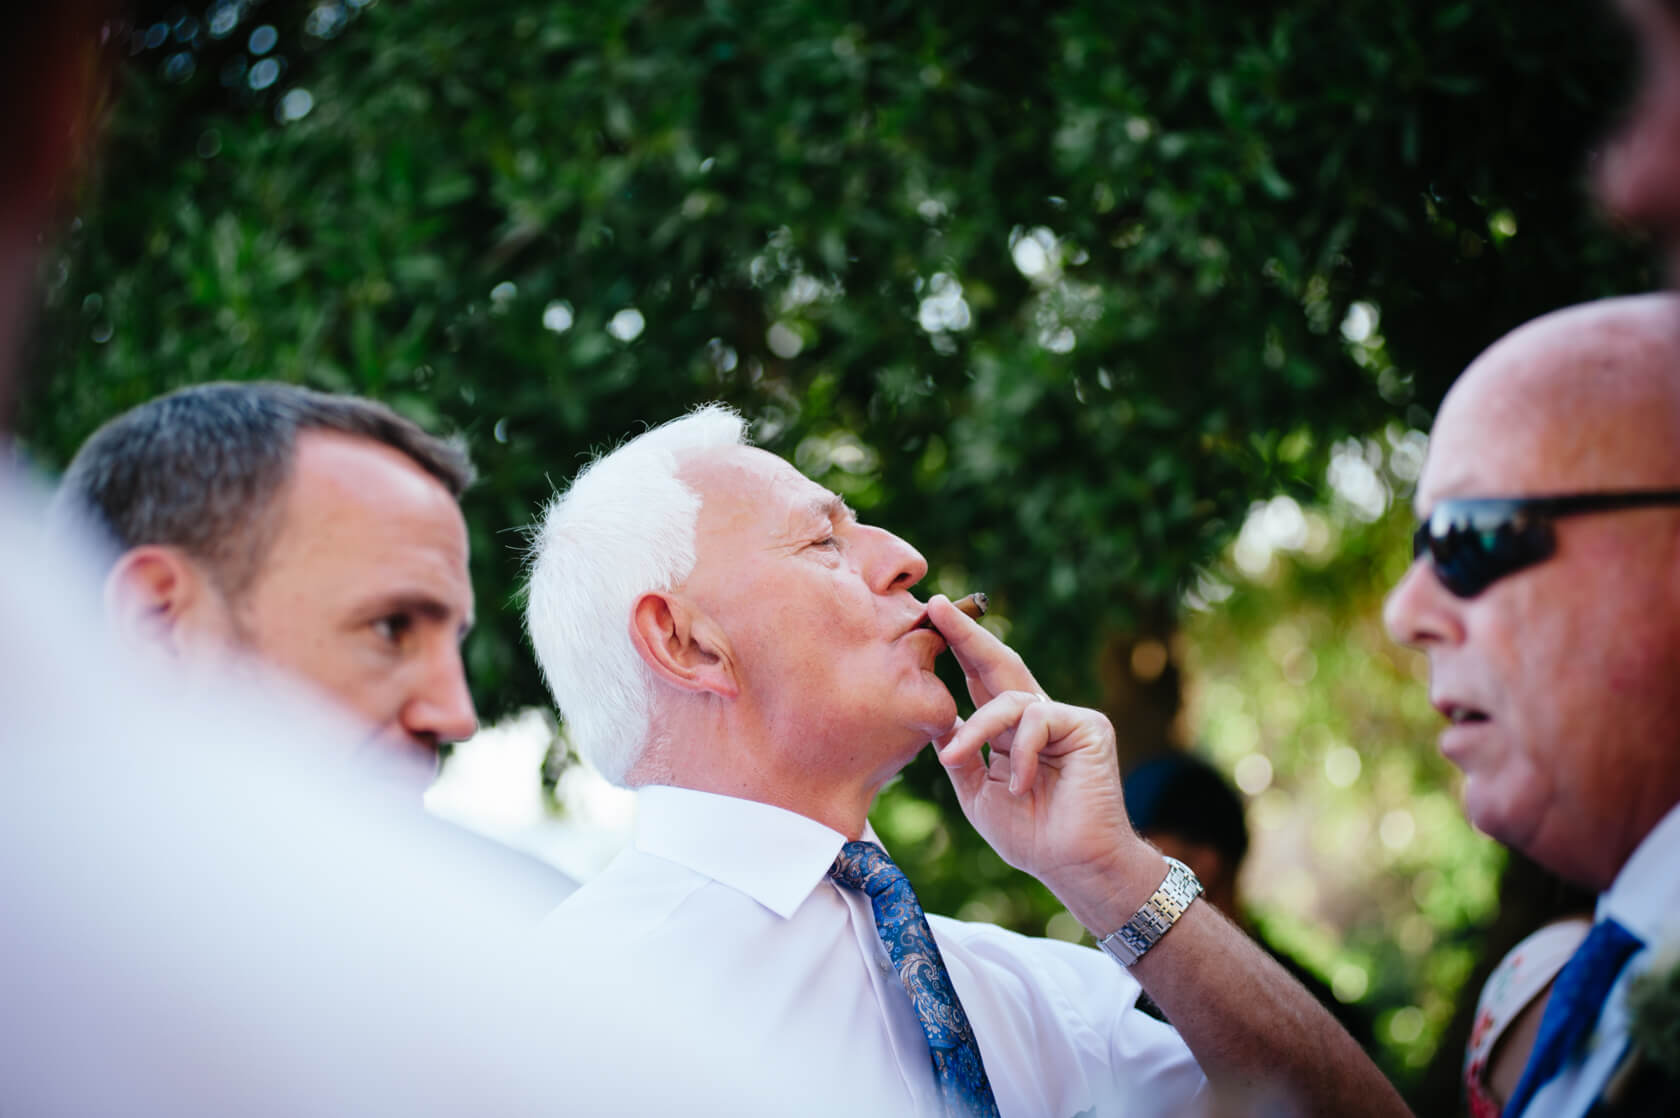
[927,595,1166,935]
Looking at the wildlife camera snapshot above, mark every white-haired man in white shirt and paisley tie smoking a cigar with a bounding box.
[528,405,1404,1116]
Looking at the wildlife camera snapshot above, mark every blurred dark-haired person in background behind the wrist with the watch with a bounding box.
[1126,751,1376,1052]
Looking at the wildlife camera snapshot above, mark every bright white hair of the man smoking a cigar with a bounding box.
[526,403,748,785]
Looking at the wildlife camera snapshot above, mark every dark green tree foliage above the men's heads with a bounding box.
[25,0,1630,715]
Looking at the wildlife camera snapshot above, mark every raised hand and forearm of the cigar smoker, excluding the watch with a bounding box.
[927,597,1410,1116]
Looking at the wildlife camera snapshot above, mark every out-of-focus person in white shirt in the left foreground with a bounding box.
[0,0,739,1118]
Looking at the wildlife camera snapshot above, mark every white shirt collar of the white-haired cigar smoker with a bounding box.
[633,785,880,920]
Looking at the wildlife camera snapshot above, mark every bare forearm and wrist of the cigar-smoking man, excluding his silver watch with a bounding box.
[1058,851,1410,1115]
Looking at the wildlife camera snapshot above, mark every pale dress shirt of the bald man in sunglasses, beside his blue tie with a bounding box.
[1525,796,1680,1118]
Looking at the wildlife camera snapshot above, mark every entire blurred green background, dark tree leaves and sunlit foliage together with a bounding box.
[20,0,1655,1113]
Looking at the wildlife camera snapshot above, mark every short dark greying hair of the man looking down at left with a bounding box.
[54,382,474,599]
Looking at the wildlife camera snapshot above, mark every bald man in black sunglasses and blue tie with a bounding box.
[1384,294,1680,1118]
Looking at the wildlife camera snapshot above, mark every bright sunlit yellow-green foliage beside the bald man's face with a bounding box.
[1184,427,1504,1079]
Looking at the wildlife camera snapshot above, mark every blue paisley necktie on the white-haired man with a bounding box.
[828,842,998,1118]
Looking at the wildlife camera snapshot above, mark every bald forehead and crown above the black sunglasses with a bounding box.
[1418,296,1680,511]
